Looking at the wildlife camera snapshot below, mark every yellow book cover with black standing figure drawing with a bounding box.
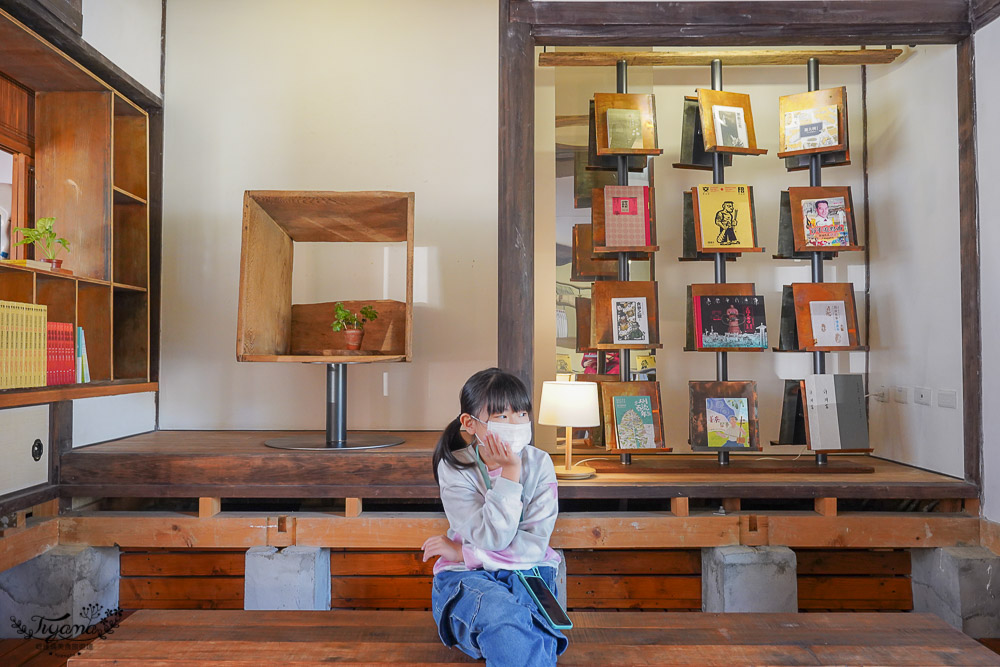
[693,185,757,252]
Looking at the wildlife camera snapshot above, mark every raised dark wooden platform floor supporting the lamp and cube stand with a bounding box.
[59,431,978,500]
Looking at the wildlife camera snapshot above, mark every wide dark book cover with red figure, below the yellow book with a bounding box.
[695,295,767,349]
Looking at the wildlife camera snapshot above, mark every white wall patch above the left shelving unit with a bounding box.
[83,0,163,95]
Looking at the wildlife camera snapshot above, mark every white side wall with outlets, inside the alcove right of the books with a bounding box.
[868,46,964,477]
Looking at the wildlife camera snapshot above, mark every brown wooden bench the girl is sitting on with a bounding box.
[68,609,1000,667]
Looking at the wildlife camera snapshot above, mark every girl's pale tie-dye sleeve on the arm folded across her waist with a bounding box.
[462,455,559,570]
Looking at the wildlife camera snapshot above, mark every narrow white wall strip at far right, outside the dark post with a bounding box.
[975,21,1000,521]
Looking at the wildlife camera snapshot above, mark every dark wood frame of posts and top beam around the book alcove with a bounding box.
[497,0,984,492]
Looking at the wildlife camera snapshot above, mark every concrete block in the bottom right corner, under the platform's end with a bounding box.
[910,547,1000,639]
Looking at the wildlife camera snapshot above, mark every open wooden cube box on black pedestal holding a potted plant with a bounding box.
[236,190,413,363]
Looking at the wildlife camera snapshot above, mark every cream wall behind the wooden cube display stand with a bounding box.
[160,0,499,429]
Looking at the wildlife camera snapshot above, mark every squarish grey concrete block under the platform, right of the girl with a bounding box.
[701,546,799,613]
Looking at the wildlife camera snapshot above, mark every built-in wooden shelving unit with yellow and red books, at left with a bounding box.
[0,13,157,408]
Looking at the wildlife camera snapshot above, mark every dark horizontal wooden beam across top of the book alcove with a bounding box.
[509,0,968,46]
